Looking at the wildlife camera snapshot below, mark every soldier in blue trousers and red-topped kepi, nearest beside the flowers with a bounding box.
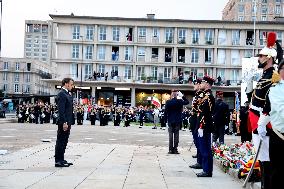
[196,76,215,177]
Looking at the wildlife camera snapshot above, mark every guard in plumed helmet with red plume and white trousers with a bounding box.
[246,32,283,189]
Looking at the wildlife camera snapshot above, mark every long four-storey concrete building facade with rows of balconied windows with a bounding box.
[46,15,284,106]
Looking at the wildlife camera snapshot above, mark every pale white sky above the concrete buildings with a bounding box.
[1,0,228,58]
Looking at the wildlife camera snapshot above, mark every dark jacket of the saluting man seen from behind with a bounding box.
[165,96,189,124]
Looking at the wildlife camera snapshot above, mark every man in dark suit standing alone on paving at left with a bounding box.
[55,78,74,167]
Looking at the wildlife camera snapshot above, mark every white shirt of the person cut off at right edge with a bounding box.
[269,80,284,133]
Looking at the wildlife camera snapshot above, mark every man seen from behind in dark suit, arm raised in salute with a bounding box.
[165,90,189,154]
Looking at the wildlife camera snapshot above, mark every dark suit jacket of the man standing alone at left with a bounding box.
[57,89,74,125]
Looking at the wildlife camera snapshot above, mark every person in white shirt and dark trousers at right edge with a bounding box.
[259,60,284,189]
